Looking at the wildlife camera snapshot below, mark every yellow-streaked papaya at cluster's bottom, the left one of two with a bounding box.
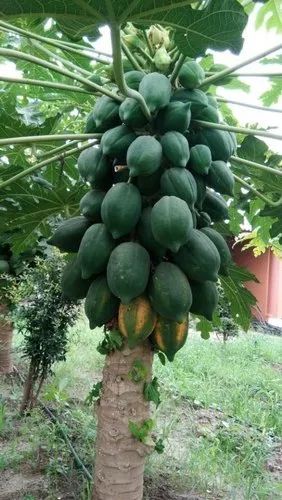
[118,295,157,349]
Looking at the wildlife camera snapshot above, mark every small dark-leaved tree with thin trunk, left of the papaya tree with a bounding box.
[11,255,79,413]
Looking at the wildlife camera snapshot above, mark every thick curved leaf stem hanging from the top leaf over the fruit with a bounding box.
[110,22,152,121]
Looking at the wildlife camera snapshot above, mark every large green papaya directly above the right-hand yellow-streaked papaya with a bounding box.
[148,262,192,322]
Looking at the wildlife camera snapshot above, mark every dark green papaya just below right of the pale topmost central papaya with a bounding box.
[155,101,191,134]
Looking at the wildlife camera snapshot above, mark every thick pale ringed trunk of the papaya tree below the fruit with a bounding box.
[92,343,153,500]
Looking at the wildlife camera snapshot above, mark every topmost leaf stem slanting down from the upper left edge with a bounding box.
[0,20,111,64]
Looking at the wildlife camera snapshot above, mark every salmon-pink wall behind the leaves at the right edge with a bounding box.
[232,245,282,321]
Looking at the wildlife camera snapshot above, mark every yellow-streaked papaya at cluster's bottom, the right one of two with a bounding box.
[150,316,188,361]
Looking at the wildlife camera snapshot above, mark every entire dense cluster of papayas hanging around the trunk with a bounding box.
[50,61,236,361]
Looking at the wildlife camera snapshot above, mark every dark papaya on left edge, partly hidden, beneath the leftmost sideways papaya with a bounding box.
[62,256,92,300]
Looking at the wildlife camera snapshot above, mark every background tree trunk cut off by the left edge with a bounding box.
[0,304,13,373]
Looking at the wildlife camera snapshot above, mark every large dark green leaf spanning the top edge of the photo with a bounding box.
[0,0,247,57]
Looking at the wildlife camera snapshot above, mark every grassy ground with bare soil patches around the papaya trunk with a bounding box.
[0,319,282,500]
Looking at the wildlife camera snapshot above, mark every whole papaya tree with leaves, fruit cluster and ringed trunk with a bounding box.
[0,0,282,500]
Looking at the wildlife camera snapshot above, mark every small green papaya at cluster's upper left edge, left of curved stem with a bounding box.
[93,95,120,132]
